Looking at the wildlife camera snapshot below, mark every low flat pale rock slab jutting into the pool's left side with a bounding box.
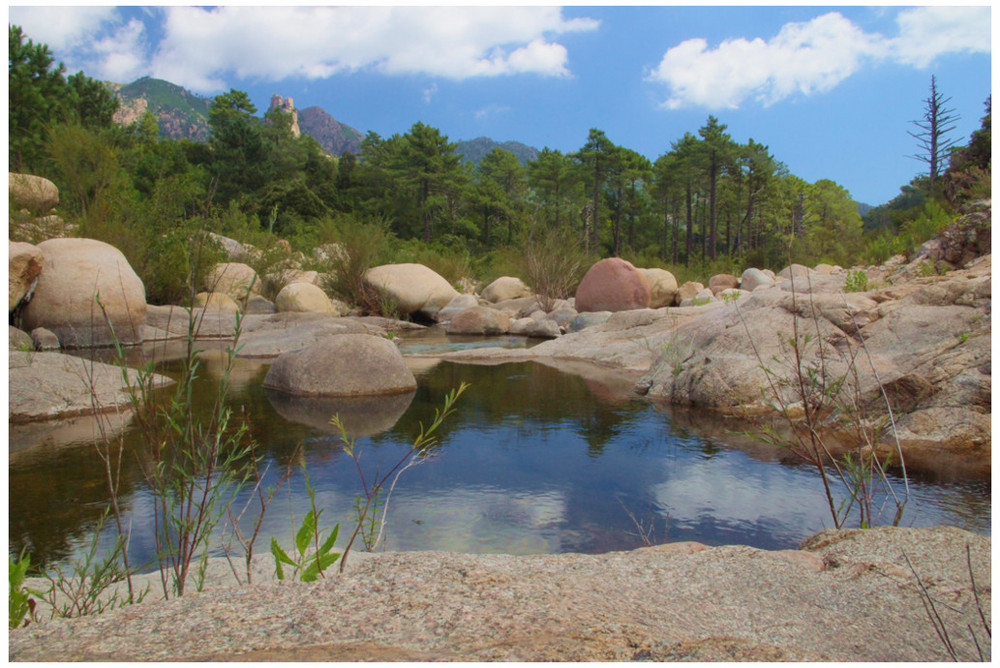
[7,350,173,423]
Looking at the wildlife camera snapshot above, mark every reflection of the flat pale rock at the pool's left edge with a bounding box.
[7,409,132,468]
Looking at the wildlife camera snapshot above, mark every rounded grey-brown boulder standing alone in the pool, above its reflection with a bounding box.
[264,334,417,396]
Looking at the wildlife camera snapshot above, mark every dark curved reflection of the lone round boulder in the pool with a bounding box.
[264,388,416,438]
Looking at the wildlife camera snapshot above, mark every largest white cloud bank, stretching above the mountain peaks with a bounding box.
[152,6,598,92]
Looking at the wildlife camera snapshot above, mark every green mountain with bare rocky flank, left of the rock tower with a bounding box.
[106,77,212,142]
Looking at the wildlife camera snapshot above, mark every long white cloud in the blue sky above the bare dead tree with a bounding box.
[647,7,990,109]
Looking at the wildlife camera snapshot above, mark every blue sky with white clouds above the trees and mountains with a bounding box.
[9,4,992,205]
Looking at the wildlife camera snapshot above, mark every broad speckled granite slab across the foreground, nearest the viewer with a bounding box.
[8,527,991,661]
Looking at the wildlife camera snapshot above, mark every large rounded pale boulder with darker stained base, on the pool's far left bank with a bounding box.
[23,239,146,348]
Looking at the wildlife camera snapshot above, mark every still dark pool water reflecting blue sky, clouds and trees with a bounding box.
[9,335,991,563]
